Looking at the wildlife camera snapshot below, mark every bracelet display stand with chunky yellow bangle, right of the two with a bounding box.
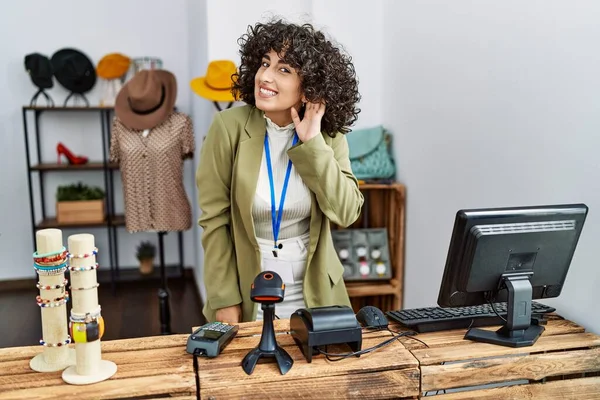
[62,233,117,385]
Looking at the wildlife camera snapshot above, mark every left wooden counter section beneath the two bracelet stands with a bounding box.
[0,335,196,400]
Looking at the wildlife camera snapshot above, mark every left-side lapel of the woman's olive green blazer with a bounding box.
[235,108,267,247]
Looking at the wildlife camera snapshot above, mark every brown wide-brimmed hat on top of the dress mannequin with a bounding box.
[115,69,177,130]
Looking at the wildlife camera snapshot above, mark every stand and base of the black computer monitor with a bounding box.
[465,272,544,347]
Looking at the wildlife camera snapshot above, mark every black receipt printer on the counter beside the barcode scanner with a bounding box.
[290,306,362,362]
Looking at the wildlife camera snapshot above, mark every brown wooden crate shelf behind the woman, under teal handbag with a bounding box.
[332,183,406,312]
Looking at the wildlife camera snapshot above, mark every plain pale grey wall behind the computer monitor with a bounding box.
[382,0,600,333]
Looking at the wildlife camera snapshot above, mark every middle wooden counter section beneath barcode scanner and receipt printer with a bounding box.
[198,319,420,400]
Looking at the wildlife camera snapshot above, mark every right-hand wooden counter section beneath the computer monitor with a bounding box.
[396,315,600,399]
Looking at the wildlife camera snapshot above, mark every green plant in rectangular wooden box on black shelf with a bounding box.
[56,182,104,224]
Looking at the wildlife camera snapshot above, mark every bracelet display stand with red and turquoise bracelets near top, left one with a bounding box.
[29,229,75,372]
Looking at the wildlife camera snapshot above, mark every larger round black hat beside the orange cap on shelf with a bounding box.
[52,49,96,94]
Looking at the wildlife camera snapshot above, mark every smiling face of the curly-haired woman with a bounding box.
[254,50,302,123]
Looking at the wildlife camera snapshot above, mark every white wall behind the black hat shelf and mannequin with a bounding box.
[0,0,199,280]
